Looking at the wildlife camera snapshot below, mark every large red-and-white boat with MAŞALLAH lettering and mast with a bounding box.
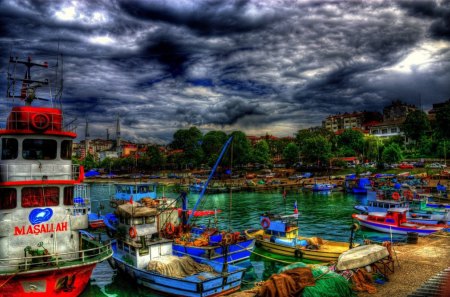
[0,58,112,297]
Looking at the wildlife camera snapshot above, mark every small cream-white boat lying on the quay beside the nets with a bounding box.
[336,244,389,270]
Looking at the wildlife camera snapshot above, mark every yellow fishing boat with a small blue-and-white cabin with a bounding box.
[245,213,353,262]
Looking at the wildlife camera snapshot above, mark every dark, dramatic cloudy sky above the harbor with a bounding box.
[0,0,450,143]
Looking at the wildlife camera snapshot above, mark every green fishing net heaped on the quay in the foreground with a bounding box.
[278,262,354,297]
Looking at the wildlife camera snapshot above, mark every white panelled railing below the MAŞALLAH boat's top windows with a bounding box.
[0,163,80,182]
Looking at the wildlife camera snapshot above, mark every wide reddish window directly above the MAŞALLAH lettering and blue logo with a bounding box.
[22,187,59,207]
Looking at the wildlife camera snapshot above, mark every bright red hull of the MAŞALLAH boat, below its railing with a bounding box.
[0,264,96,297]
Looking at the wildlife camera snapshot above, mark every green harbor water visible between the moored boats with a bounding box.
[81,184,403,297]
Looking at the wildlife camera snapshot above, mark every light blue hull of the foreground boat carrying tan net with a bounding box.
[113,255,245,297]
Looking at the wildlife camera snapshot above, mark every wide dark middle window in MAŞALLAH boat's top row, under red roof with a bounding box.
[22,139,58,160]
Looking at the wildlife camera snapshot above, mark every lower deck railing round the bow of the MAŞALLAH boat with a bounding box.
[0,237,113,273]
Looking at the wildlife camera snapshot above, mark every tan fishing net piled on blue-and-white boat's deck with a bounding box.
[147,256,214,278]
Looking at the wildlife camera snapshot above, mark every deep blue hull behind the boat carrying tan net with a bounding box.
[172,239,255,263]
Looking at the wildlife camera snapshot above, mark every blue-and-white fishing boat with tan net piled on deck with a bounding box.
[109,203,245,297]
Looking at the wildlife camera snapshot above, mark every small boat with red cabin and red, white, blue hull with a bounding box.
[352,208,444,236]
